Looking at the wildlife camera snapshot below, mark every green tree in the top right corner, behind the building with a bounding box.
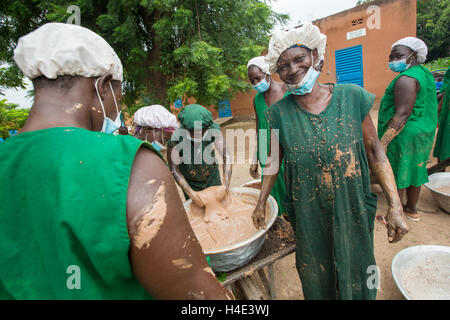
[417,0,450,61]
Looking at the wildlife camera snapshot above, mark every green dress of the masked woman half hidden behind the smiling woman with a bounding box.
[255,92,289,215]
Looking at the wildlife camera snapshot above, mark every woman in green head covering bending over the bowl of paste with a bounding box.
[167,104,232,207]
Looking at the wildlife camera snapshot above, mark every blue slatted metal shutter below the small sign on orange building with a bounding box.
[335,45,364,88]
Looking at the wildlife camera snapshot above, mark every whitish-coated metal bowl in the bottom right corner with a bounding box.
[391,245,450,300]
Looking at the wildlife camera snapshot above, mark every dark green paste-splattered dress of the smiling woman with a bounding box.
[265,84,377,299]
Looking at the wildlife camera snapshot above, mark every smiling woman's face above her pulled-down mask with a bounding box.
[277,47,317,85]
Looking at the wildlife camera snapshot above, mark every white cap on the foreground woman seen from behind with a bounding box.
[14,23,123,81]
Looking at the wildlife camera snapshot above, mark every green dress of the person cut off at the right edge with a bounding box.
[433,68,450,161]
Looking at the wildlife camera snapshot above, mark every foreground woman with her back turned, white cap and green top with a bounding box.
[0,23,232,300]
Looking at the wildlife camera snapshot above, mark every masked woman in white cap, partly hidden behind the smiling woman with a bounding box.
[247,56,289,217]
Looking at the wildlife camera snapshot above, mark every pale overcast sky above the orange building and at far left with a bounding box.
[0,0,357,108]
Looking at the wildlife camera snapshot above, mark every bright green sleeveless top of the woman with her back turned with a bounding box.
[0,127,155,299]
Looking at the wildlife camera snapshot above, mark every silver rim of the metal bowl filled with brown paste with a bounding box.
[184,187,278,255]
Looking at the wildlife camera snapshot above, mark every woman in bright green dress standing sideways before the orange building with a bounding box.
[378,37,437,221]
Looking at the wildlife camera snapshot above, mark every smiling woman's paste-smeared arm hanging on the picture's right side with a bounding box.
[362,114,409,243]
